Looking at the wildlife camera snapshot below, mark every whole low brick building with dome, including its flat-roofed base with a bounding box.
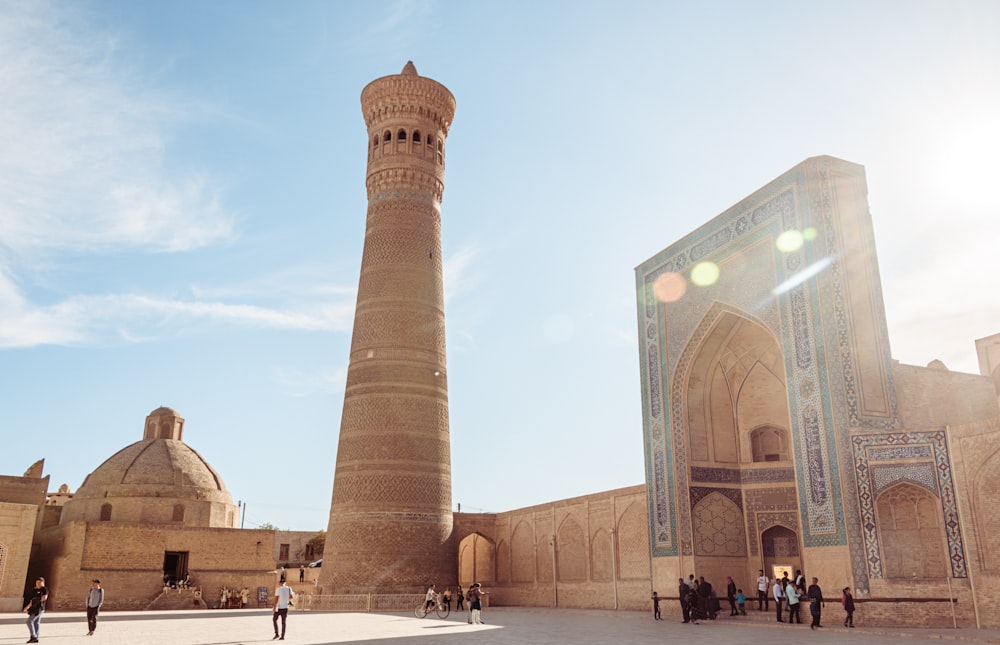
[28,407,275,611]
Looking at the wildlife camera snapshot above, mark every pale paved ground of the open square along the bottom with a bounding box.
[0,608,1000,645]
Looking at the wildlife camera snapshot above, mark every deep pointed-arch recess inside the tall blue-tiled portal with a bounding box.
[672,307,798,583]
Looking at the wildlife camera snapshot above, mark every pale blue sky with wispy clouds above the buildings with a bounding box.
[0,0,1000,530]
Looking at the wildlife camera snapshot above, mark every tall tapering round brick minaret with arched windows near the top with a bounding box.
[320,62,457,594]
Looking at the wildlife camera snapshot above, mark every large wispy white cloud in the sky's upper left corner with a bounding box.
[0,2,234,252]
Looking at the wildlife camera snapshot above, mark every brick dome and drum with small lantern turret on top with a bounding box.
[60,407,239,528]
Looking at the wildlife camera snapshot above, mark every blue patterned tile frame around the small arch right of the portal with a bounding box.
[851,430,968,579]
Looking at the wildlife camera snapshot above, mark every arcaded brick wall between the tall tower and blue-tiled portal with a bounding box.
[455,485,651,609]
